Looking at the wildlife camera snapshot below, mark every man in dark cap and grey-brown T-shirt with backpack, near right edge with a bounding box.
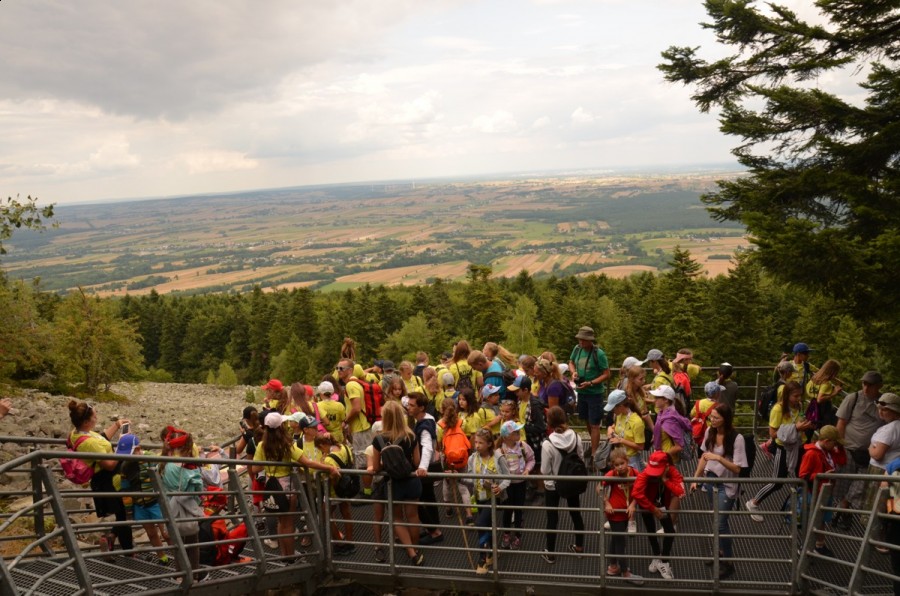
[832,370,884,530]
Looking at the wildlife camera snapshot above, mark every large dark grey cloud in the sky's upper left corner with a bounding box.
[0,0,436,120]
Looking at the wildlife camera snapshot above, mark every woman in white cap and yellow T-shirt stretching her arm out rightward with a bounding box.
[250,412,340,557]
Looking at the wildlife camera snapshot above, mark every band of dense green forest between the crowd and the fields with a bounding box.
[0,250,896,388]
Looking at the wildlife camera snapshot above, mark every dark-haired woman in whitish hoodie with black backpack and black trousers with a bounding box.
[541,406,584,565]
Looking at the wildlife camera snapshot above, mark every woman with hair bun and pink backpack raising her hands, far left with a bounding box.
[69,399,134,551]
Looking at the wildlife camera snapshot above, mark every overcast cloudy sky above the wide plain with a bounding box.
[0,0,808,203]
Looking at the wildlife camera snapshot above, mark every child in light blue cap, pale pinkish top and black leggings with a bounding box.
[497,420,534,550]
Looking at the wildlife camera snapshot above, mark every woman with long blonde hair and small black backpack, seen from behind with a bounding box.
[372,401,425,567]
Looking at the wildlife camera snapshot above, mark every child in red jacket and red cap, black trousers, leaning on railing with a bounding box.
[632,452,685,579]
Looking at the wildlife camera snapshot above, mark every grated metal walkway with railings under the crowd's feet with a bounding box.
[0,437,897,596]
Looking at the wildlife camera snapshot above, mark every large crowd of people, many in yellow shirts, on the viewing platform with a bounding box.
[61,327,900,584]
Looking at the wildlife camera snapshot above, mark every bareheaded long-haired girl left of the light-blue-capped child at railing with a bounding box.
[468,428,509,575]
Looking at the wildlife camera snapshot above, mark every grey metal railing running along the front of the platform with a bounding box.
[0,437,900,596]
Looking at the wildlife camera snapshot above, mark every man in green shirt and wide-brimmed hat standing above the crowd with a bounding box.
[569,327,609,462]
